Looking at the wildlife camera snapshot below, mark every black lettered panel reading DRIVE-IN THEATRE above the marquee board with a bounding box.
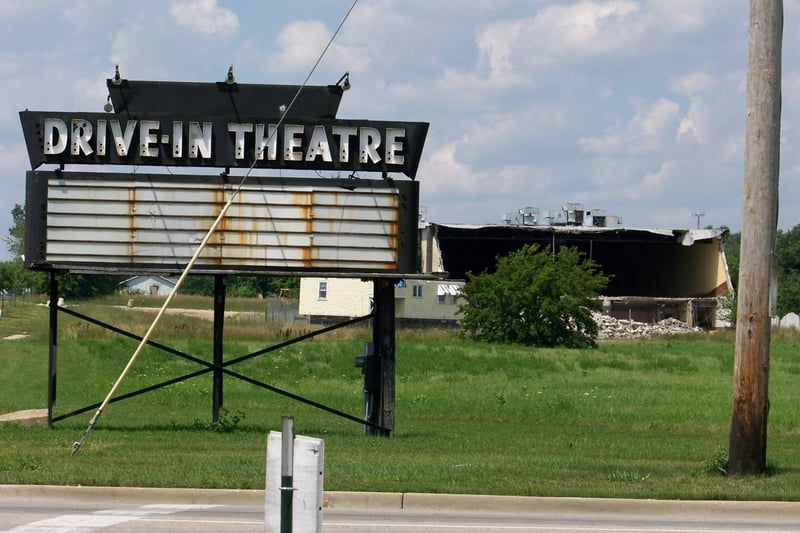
[21,115,427,178]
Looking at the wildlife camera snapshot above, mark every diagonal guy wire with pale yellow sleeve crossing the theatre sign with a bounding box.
[70,0,358,455]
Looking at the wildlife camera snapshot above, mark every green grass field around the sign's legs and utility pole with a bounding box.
[0,298,800,500]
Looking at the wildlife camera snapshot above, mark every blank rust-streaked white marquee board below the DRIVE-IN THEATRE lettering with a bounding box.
[29,172,416,273]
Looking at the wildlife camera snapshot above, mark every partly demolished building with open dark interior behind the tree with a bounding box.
[420,223,732,329]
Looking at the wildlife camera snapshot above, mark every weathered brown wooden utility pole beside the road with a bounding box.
[728,0,783,474]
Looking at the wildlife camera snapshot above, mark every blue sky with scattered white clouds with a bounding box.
[0,0,800,260]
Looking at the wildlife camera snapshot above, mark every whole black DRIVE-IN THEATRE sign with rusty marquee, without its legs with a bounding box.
[20,79,428,274]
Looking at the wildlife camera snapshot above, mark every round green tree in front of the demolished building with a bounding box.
[459,244,609,348]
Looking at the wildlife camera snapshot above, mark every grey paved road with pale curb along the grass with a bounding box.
[0,485,800,533]
